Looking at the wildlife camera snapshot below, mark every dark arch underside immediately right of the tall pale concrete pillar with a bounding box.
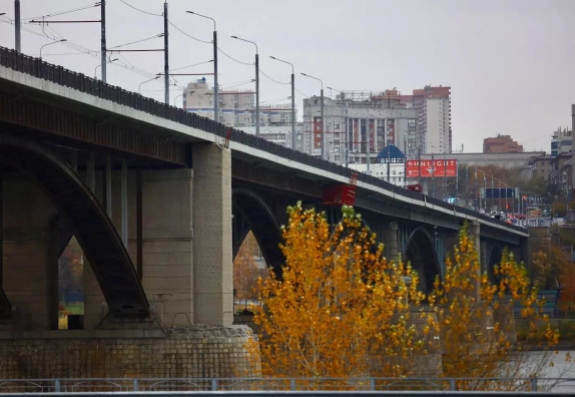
[232,187,285,277]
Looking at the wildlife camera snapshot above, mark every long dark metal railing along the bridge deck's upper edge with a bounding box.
[0,47,525,232]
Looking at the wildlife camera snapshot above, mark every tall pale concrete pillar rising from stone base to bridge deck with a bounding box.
[192,144,233,326]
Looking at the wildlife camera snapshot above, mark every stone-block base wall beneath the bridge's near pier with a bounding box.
[0,327,260,378]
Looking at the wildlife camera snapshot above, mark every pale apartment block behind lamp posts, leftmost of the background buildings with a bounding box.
[183,78,292,127]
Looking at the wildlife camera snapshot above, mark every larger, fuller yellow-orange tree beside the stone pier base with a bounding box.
[254,205,430,378]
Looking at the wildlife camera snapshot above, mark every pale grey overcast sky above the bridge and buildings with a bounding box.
[0,0,575,152]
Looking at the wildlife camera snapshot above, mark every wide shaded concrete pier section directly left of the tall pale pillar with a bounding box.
[128,168,194,326]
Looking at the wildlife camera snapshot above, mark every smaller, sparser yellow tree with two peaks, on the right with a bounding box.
[430,223,558,390]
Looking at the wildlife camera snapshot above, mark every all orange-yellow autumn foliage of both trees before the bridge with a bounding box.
[249,205,558,390]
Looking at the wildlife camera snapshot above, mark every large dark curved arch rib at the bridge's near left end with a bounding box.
[0,135,149,316]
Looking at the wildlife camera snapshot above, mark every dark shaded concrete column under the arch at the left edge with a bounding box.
[3,173,58,331]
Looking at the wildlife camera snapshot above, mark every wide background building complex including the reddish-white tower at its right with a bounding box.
[304,86,452,163]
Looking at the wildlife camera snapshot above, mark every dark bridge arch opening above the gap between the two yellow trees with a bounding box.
[404,227,441,294]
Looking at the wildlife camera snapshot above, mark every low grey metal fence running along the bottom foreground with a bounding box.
[0,378,575,393]
